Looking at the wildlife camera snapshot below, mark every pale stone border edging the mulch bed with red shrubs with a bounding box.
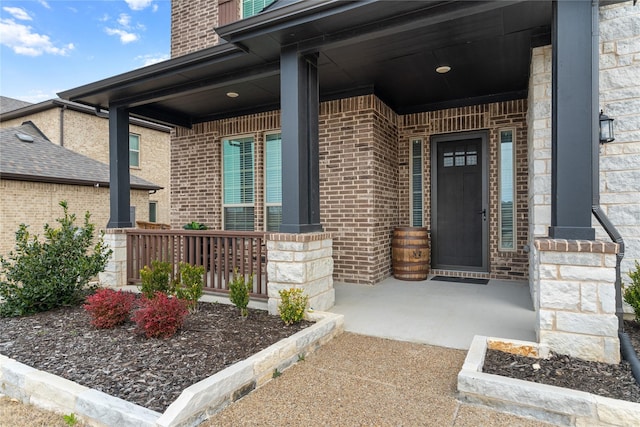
[0,312,344,427]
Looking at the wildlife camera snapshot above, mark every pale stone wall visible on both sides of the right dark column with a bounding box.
[527,2,640,280]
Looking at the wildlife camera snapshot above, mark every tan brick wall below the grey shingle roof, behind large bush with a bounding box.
[0,179,149,255]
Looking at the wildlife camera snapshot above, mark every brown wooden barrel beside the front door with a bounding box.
[391,227,430,280]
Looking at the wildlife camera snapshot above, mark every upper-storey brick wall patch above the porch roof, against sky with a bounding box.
[171,0,218,58]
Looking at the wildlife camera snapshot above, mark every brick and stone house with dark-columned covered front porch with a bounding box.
[60,0,640,361]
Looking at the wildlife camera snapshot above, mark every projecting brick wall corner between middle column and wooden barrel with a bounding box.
[320,96,398,284]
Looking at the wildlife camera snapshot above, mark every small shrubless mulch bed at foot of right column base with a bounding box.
[483,321,640,403]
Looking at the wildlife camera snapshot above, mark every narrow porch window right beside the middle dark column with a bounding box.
[264,133,282,231]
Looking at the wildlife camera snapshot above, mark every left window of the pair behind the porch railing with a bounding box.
[222,137,254,231]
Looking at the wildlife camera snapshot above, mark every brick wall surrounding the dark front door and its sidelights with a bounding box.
[399,100,529,279]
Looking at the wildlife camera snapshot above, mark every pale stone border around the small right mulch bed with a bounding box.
[458,335,640,426]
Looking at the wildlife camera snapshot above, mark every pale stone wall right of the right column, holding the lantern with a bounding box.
[594,2,640,276]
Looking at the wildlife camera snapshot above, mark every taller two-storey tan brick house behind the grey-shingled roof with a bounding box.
[0,96,171,226]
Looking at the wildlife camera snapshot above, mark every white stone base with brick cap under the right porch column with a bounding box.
[531,238,620,363]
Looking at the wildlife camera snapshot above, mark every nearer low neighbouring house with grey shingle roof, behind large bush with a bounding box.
[0,123,161,256]
